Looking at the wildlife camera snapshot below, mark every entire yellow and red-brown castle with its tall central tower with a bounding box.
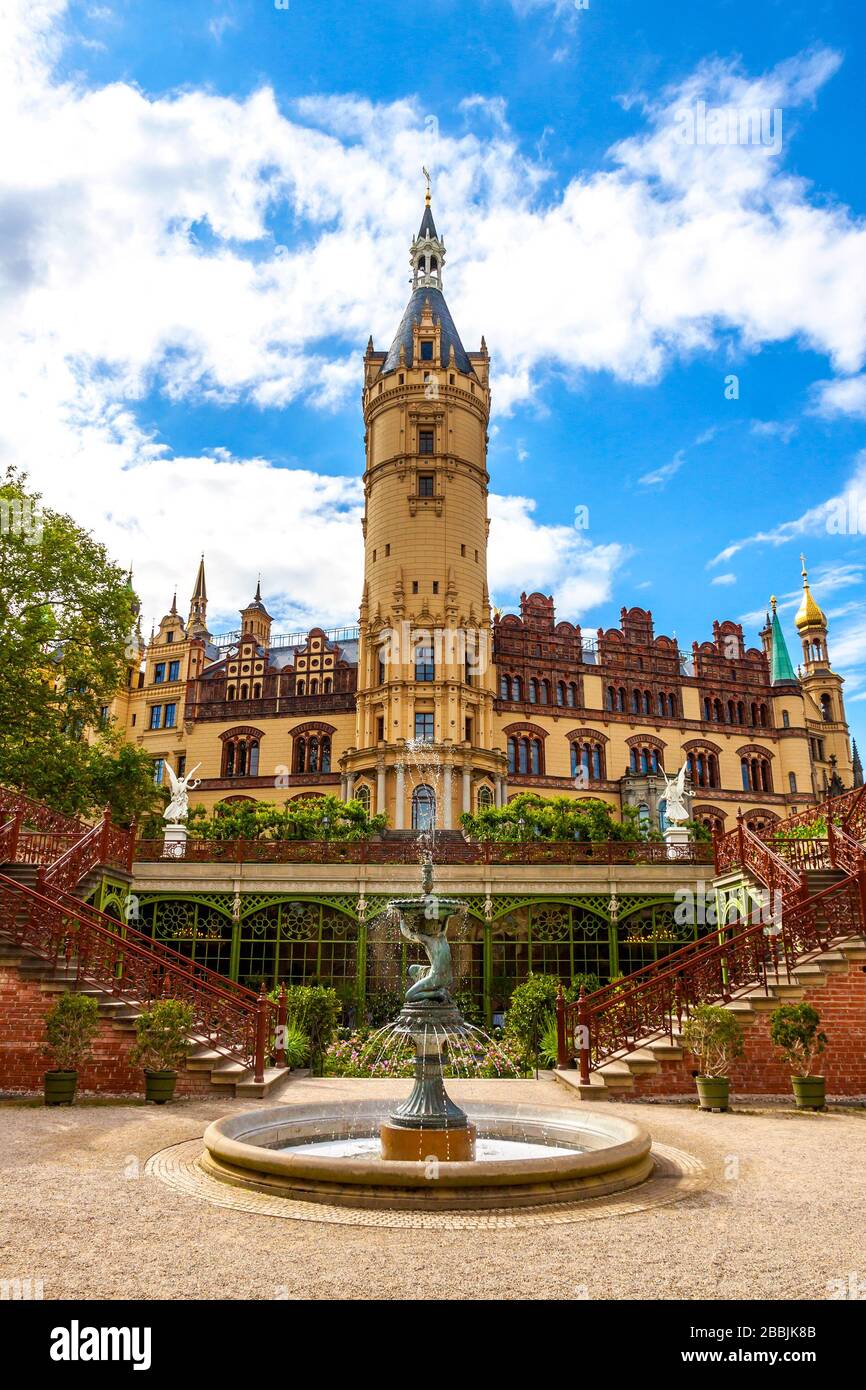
[103,189,862,830]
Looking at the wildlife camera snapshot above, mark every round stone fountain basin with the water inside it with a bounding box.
[200,1101,653,1211]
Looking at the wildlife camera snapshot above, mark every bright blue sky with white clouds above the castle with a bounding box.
[0,0,866,750]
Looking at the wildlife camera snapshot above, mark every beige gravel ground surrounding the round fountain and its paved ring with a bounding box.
[0,1079,866,1300]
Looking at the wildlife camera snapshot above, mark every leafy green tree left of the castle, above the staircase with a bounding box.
[0,468,153,816]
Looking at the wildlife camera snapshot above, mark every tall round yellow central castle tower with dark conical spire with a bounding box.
[342,186,506,830]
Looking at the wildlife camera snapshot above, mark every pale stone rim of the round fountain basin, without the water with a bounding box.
[204,1099,652,1187]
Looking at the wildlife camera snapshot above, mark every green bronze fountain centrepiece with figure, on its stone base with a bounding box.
[379,853,475,1162]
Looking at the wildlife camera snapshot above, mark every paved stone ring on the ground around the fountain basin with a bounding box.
[145,1138,709,1230]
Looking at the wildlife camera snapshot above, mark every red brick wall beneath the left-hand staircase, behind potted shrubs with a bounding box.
[0,965,219,1095]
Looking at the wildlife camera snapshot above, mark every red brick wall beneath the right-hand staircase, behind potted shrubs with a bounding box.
[626,960,866,1099]
